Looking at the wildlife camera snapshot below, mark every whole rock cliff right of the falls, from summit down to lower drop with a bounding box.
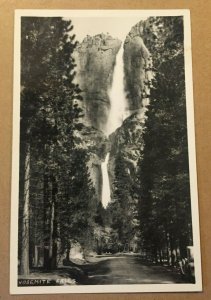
[104,21,153,194]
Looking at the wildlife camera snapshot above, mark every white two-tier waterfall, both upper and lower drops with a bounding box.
[101,44,127,207]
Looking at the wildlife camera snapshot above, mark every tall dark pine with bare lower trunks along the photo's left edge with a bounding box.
[20,17,82,274]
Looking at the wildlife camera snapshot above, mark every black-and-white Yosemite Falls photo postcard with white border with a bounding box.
[10,10,202,294]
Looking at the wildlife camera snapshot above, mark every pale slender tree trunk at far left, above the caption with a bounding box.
[20,144,30,275]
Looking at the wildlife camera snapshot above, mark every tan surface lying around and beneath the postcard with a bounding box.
[0,0,211,300]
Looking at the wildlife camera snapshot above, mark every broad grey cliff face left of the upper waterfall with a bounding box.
[74,34,121,131]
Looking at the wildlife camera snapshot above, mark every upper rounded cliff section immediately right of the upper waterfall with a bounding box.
[124,21,153,113]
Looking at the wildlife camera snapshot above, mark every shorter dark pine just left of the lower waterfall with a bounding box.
[58,149,96,257]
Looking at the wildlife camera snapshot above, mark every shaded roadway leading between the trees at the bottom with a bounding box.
[79,255,184,285]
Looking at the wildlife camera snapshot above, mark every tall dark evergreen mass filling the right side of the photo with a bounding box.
[139,17,192,264]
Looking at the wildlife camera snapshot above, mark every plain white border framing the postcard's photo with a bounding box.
[10,9,202,294]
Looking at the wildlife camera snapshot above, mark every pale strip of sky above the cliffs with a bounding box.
[71,16,146,42]
